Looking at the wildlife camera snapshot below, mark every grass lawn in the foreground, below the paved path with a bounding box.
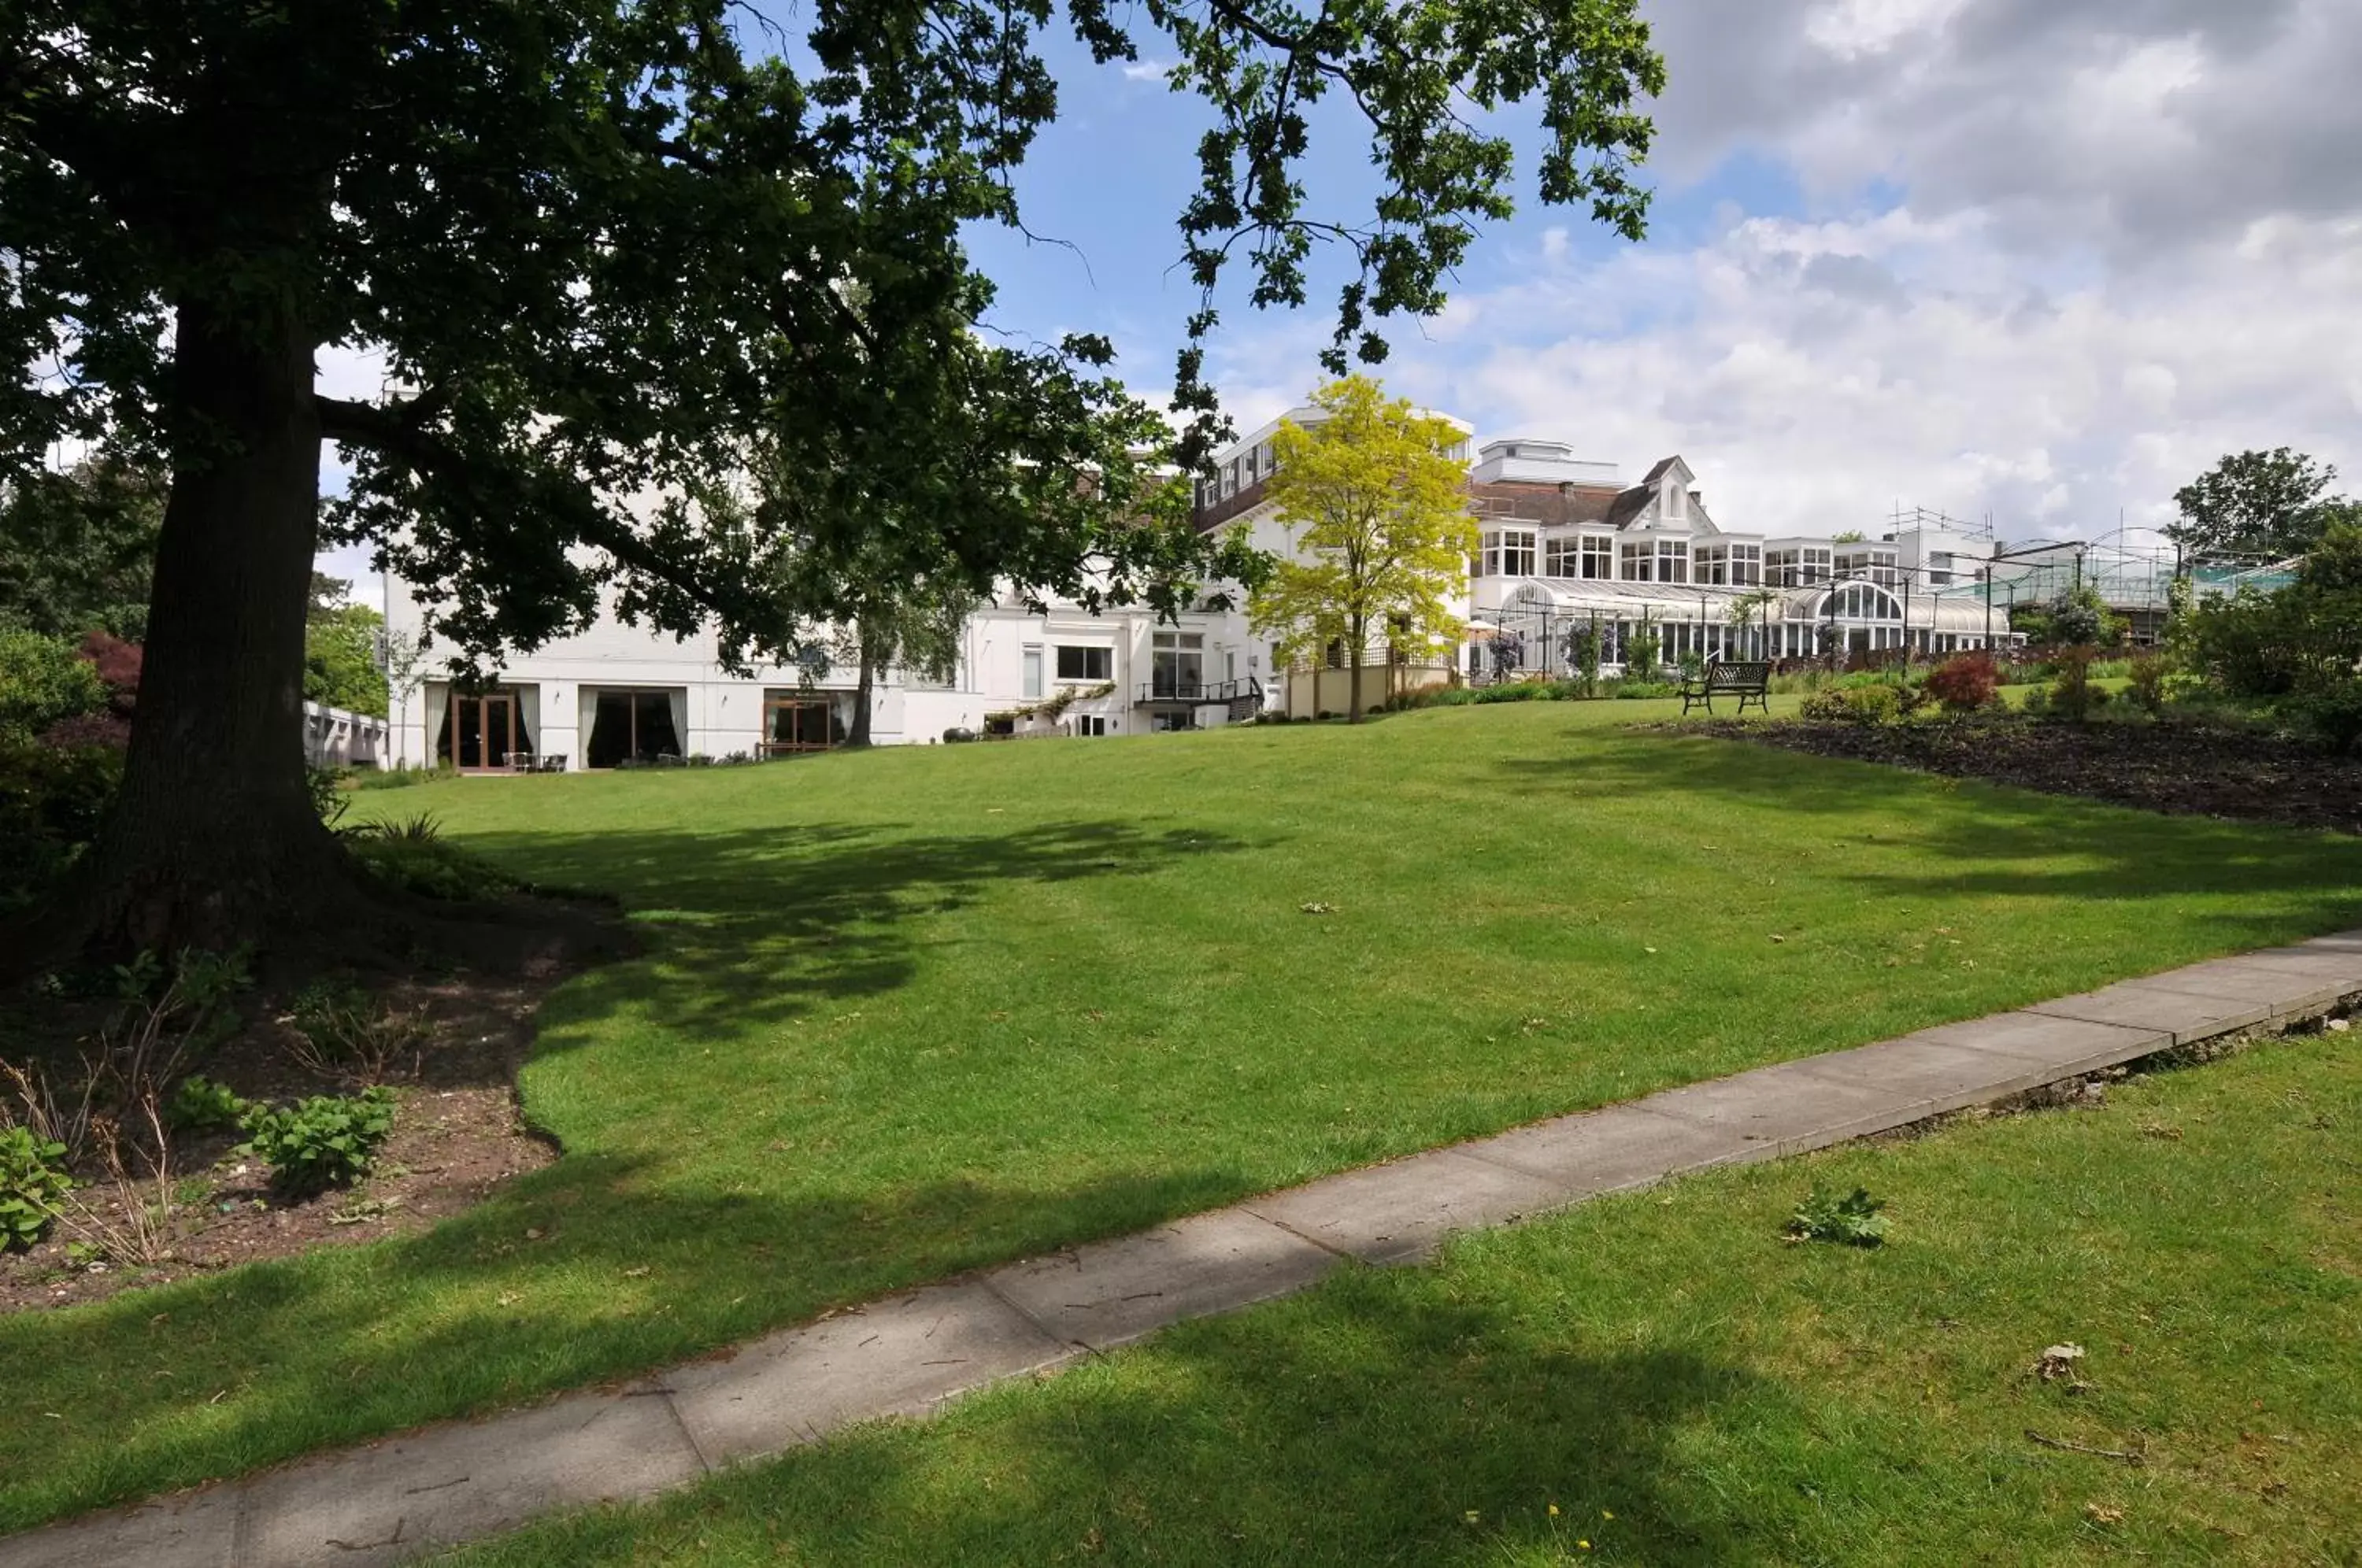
[430,1034,2362,1568]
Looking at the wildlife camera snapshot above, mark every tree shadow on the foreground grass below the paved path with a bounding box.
[463,1268,1790,1568]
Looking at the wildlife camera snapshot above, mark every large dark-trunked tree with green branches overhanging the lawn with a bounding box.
[0,0,1663,947]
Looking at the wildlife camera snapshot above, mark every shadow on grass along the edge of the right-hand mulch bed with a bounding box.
[1498,730,2362,947]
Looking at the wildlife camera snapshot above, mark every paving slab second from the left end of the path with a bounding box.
[237,1393,706,1568]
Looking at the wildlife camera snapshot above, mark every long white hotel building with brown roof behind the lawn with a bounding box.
[385,409,2008,772]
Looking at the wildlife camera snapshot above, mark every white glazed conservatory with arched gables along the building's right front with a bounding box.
[1467,579,2015,675]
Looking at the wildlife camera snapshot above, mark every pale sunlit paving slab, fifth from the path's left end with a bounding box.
[1245,1150,1573,1263]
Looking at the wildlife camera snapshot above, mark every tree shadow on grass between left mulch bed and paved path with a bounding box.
[0,1155,1242,1533]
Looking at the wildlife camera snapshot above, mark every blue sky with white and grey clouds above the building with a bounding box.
[324,0,2362,600]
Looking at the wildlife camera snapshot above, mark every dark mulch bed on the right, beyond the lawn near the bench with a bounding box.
[1682,716,2362,834]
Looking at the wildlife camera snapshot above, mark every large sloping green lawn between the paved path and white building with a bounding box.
[0,701,2362,1528]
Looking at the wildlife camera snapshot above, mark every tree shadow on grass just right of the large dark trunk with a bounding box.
[468,822,1254,1046]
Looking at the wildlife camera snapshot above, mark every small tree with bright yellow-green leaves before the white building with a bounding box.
[1247,375,1476,723]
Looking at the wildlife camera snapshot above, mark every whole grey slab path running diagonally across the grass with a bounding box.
[18,933,2362,1568]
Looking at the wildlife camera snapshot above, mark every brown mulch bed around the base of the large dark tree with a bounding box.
[0,907,628,1313]
